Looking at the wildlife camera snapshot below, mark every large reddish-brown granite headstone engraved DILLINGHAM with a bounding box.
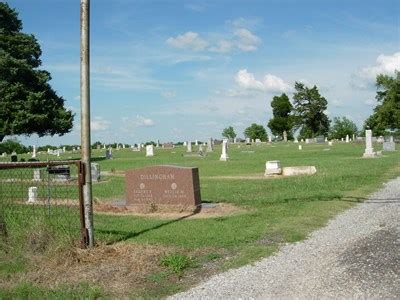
[125,166,201,212]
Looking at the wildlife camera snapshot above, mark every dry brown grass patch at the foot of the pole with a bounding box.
[25,244,174,295]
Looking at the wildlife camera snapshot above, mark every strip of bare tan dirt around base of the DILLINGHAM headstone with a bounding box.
[94,203,248,219]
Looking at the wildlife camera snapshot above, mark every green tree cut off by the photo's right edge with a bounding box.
[364,71,400,135]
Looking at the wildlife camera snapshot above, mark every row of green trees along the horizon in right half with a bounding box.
[222,71,400,141]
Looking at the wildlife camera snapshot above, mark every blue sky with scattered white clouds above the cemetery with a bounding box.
[8,0,400,145]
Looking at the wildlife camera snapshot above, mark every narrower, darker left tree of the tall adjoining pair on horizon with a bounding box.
[268,93,293,139]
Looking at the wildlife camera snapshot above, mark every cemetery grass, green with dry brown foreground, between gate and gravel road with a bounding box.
[0,143,400,298]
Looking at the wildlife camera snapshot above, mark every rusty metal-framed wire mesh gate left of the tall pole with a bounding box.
[0,161,87,247]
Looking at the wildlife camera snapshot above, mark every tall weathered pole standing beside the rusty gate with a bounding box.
[81,0,94,248]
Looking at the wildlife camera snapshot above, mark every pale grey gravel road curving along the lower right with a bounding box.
[170,177,400,299]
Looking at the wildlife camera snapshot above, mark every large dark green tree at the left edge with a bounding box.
[0,3,73,142]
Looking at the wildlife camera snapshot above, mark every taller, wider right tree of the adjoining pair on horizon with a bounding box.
[293,82,330,138]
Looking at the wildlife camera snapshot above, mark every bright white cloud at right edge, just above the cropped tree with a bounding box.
[357,52,400,80]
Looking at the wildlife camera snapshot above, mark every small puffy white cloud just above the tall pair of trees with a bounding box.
[235,69,291,92]
